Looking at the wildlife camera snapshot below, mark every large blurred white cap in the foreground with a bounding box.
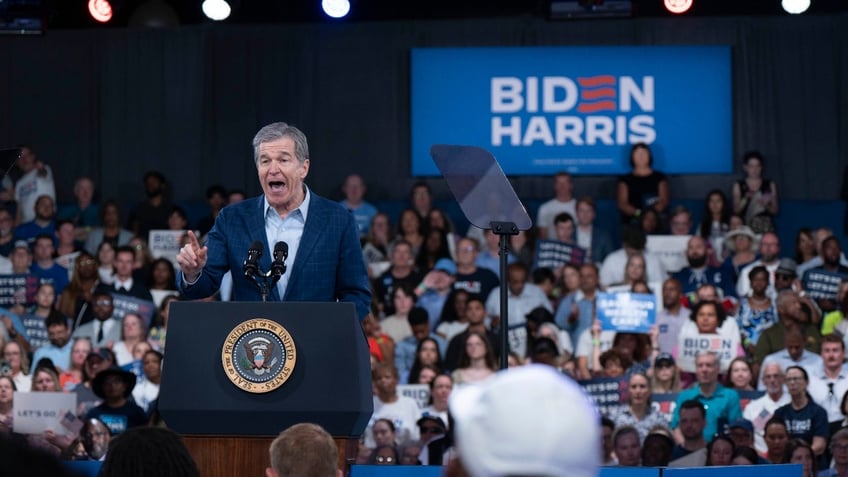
[445,365,601,477]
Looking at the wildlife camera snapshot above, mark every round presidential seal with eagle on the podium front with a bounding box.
[221,318,297,393]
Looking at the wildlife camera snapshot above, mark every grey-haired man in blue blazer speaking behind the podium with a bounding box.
[177,122,371,320]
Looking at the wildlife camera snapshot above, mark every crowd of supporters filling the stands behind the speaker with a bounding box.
[0,139,848,477]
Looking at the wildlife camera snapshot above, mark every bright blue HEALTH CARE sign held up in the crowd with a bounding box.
[596,292,657,333]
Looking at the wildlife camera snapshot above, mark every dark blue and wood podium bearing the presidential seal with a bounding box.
[159,302,373,477]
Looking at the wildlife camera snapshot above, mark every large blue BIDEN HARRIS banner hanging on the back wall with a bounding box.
[411,46,733,176]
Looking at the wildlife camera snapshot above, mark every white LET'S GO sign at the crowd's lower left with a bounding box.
[14,391,77,436]
